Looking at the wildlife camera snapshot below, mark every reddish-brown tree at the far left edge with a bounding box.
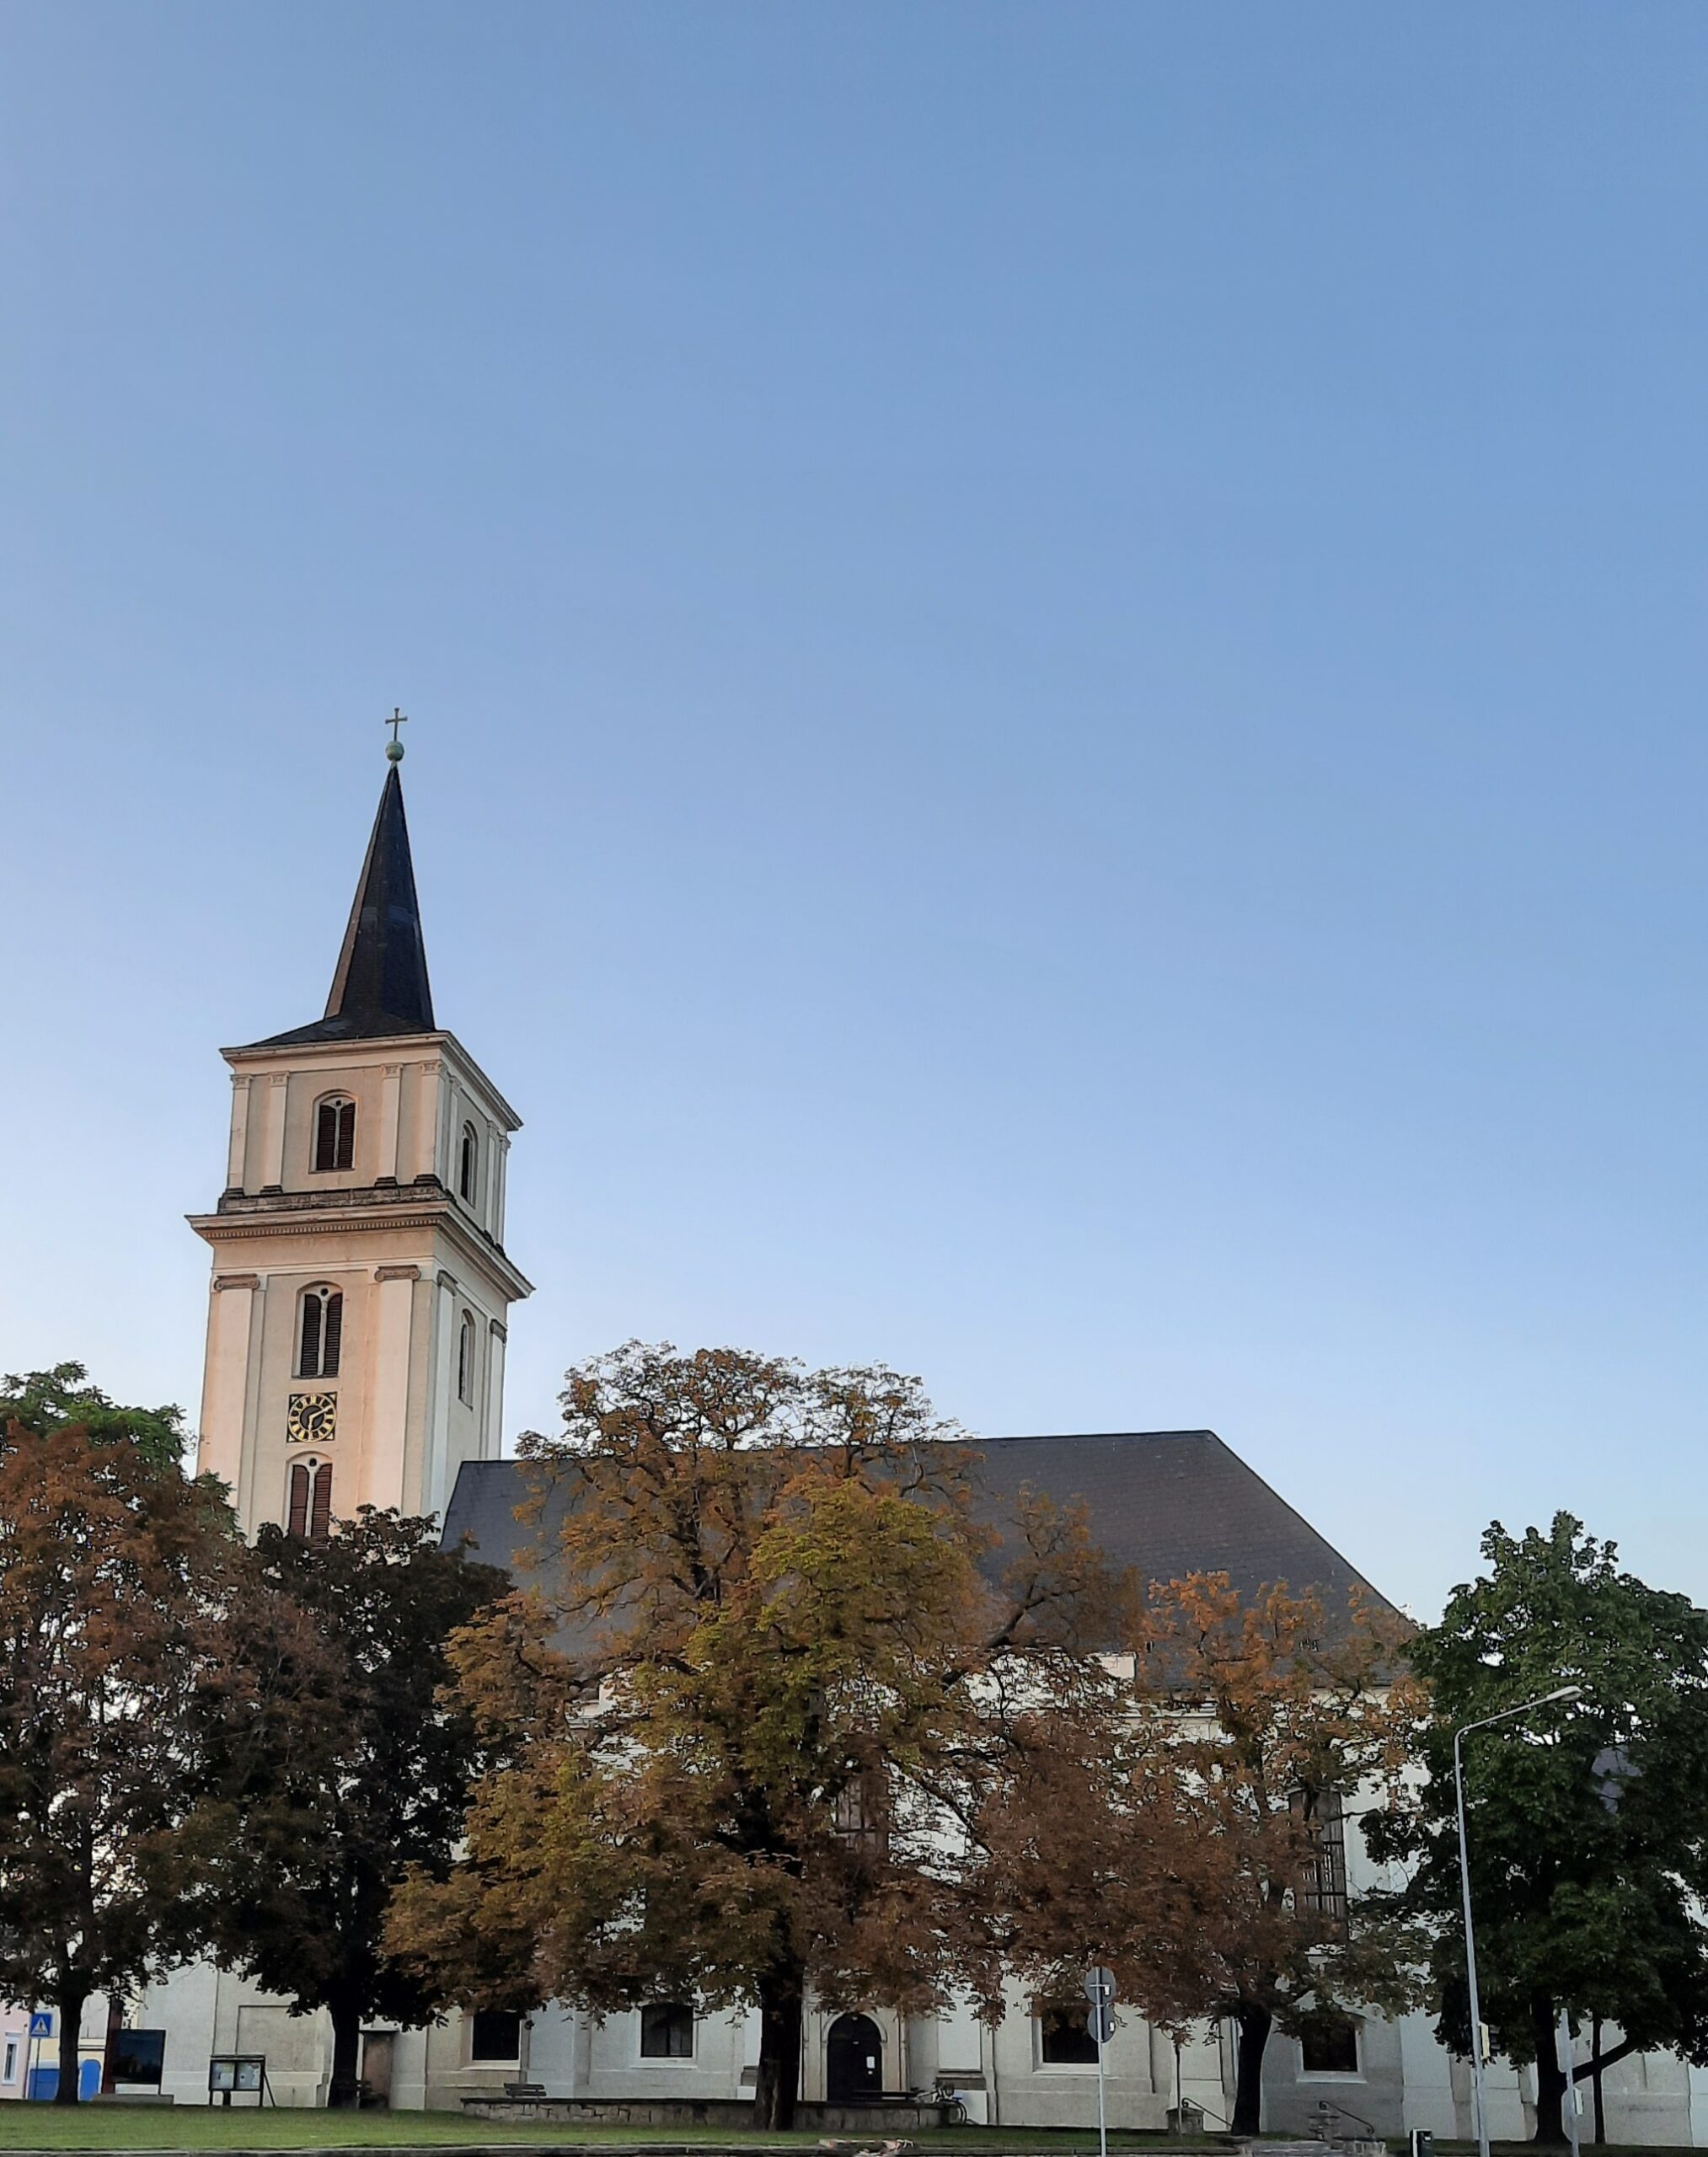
[0,1423,239,2103]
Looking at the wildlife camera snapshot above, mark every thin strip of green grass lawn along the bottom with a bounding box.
[0,2106,1198,2157]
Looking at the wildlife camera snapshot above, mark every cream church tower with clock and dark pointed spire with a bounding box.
[190,740,528,1536]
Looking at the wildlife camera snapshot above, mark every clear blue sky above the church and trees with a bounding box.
[0,0,1708,1611]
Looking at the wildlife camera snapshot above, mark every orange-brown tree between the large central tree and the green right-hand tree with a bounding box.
[1111,1575,1422,2133]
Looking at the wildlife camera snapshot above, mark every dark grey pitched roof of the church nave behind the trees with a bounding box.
[444,1430,1387,1609]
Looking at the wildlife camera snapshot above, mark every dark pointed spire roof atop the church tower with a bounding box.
[250,763,436,1048]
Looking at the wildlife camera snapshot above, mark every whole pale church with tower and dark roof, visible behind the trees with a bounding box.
[116,742,1708,2144]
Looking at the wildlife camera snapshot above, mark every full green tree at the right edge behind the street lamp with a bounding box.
[1373,1512,1708,2142]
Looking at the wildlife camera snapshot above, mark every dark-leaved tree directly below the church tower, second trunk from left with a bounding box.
[196,1506,509,2106]
